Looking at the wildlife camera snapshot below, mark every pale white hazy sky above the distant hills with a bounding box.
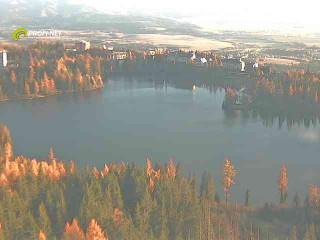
[73,0,320,31]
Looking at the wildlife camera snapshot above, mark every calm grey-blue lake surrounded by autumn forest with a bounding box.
[0,78,320,204]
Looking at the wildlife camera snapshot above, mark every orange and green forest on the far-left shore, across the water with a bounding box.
[0,42,104,101]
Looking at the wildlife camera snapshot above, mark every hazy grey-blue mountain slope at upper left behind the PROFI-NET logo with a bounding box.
[0,0,202,38]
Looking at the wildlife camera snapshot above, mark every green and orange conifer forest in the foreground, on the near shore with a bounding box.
[0,125,320,240]
